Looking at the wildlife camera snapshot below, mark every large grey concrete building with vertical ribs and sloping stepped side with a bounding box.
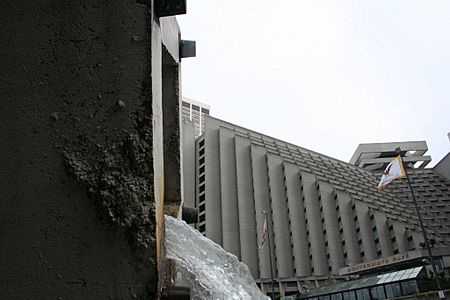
[189,117,450,294]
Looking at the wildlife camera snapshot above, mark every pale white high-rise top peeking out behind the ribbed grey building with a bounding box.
[181,97,210,138]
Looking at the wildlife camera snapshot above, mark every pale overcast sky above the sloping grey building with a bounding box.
[178,0,450,165]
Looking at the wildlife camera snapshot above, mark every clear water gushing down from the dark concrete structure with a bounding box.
[165,216,269,300]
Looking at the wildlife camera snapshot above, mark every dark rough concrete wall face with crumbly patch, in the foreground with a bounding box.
[0,0,161,299]
